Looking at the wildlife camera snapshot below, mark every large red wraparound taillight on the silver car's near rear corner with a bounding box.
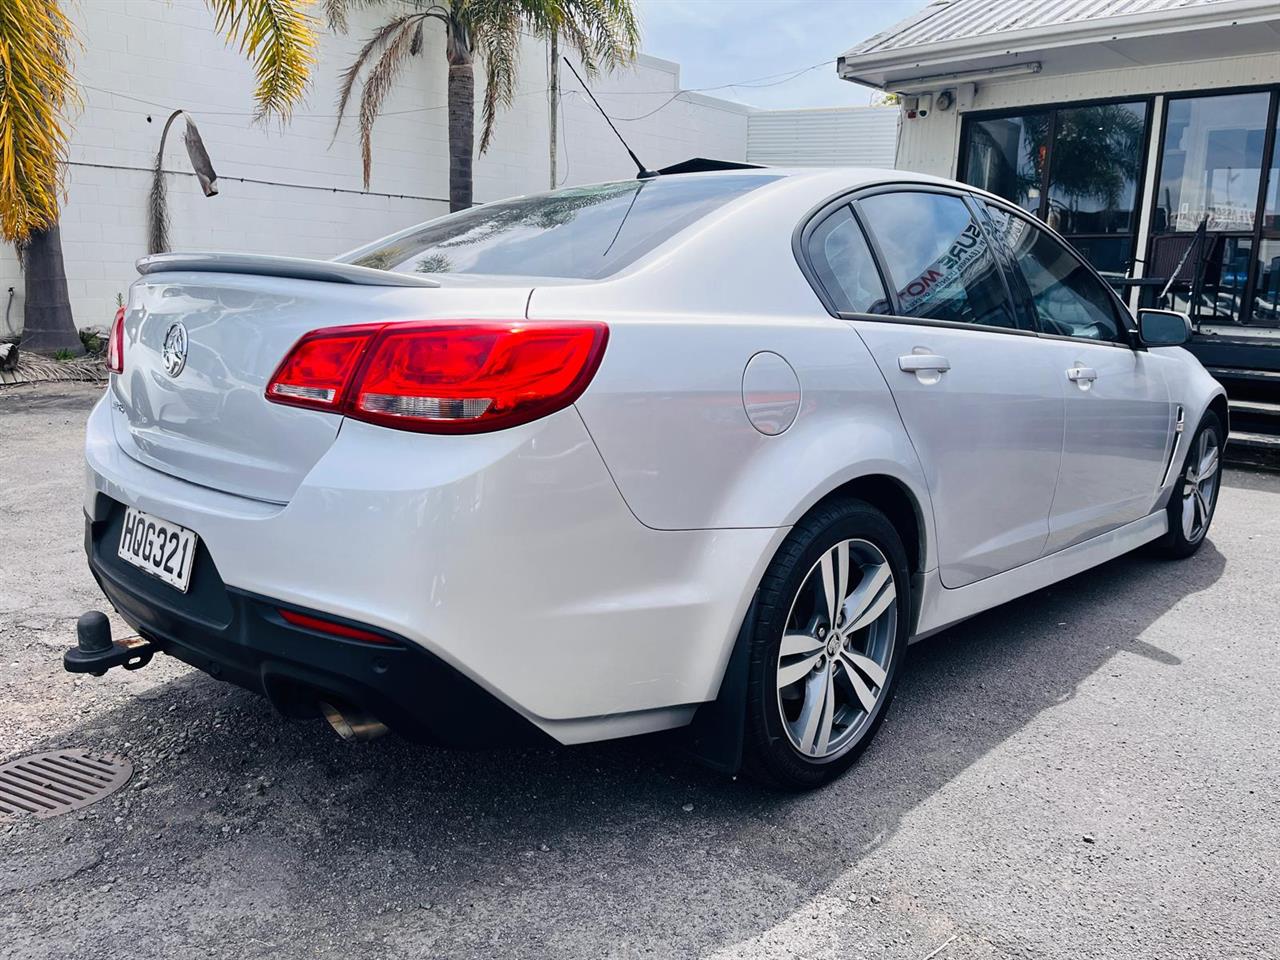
[266,323,609,434]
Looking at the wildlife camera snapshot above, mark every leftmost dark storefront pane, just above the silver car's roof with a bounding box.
[964,113,1052,214]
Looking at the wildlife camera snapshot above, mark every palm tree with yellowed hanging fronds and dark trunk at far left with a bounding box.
[0,0,317,353]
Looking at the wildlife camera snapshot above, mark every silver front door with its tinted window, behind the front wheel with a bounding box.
[987,205,1174,553]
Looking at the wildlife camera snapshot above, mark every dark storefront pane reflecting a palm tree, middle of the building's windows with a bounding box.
[1048,102,1147,236]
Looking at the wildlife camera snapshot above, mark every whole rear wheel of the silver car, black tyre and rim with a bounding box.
[744,499,911,790]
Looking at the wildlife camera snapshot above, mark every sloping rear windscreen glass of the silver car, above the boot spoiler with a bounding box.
[351,174,778,280]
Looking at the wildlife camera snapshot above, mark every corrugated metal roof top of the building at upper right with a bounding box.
[845,0,1231,58]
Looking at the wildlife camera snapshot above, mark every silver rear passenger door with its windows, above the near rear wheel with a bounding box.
[808,188,1064,588]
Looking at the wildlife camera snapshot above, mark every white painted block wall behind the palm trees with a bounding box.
[0,0,750,334]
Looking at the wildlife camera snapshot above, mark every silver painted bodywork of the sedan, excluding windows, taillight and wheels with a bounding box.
[86,170,1221,742]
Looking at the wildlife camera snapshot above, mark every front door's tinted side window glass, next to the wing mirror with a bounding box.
[987,205,1125,343]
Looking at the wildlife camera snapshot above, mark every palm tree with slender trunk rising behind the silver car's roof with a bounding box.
[325,0,640,211]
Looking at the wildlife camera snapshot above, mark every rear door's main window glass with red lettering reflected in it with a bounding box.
[859,193,1016,326]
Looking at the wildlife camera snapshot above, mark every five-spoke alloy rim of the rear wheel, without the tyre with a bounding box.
[777,540,897,760]
